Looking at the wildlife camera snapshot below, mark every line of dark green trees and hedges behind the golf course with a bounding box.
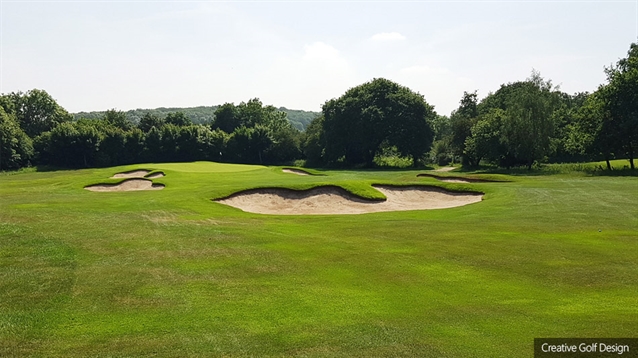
[0,44,638,170]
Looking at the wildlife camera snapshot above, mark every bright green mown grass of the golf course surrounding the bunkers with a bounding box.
[0,162,638,357]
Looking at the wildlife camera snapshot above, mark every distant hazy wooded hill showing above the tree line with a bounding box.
[73,106,321,131]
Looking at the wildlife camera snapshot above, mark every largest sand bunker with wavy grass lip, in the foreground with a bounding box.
[215,185,483,215]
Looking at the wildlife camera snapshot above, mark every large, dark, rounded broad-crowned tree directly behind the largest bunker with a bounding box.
[323,78,436,166]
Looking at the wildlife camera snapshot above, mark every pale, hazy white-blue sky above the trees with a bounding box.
[0,0,638,115]
